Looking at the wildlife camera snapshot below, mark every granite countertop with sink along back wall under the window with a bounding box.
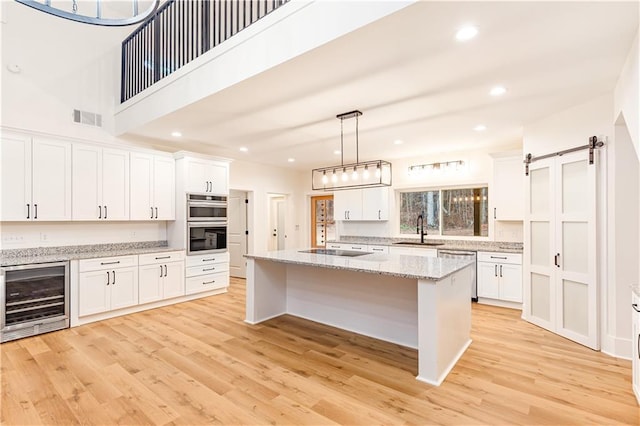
[330,236,523,253]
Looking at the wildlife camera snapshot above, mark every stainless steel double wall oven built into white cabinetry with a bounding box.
[187,194,228,255]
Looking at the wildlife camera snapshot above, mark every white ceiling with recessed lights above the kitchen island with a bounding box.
[3,0,639,170]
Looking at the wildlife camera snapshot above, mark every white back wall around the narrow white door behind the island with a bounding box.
[229,161,311,253]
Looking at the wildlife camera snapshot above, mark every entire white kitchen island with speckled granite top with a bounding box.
[245,250,473,385]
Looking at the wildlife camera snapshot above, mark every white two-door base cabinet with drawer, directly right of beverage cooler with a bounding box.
[78,256,138,317]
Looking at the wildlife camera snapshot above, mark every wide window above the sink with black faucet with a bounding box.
[400,187,489,237]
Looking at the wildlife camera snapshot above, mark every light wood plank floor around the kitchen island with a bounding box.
[0,279,640,425]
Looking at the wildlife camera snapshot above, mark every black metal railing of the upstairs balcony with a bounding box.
[120,0,290,102]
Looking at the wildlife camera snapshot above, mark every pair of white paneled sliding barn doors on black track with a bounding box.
[523,151,599,349]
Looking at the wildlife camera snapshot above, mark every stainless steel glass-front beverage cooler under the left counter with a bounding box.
[0,262,69,342]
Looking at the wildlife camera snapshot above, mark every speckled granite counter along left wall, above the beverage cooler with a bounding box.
[0,241,184,266]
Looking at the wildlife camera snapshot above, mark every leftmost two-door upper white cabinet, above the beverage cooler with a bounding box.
[0,136,71,221]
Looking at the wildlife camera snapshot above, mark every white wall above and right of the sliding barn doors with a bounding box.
[523,93,638,357]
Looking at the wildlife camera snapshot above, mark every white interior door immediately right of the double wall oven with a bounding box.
[227,189,249,278]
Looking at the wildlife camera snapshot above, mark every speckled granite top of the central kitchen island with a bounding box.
[245,250,473,281]
